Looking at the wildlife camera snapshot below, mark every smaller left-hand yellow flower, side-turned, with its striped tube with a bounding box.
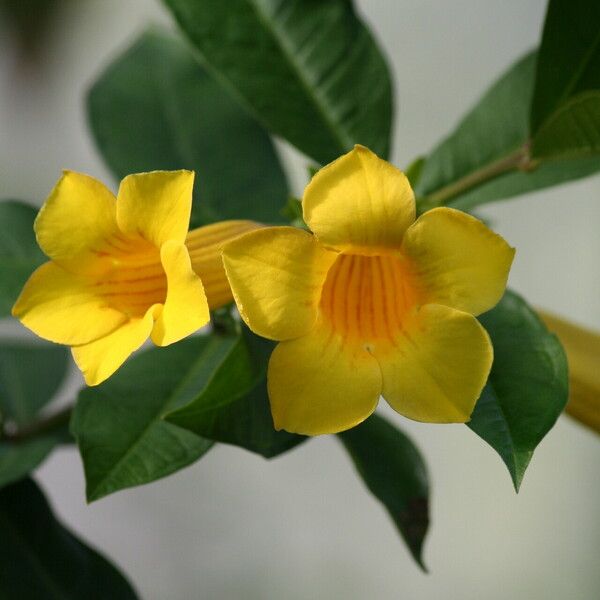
[12,171,256,385]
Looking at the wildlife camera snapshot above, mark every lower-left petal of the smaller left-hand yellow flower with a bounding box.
[12,262,127,345]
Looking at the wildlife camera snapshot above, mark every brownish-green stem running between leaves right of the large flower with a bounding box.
[425,142,534,208]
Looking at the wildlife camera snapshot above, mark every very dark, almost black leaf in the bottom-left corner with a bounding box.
[0,479,137,600]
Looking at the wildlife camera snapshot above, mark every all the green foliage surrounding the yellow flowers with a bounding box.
[0,0,600,580]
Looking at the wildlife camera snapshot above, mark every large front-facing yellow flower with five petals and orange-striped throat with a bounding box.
[223,146,514,435]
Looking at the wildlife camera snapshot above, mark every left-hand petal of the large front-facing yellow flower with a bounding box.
[223,227,337,340]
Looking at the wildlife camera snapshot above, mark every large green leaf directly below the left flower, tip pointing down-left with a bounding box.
[71,335,237,502]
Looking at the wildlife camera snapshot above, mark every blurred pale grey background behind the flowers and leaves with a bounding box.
[0,0,600,600]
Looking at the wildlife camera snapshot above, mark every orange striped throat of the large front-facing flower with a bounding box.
[320,254,418,349]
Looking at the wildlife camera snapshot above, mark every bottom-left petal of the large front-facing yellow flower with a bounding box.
[267,324,381,435]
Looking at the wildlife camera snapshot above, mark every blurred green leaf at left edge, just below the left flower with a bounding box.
[0,340,69,426]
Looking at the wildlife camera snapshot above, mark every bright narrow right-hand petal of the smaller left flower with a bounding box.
[152,242,210,346]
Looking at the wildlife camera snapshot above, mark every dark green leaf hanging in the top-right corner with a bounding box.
[531,0,600,134]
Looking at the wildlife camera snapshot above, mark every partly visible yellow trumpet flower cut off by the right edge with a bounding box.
[538,310,600,433]
